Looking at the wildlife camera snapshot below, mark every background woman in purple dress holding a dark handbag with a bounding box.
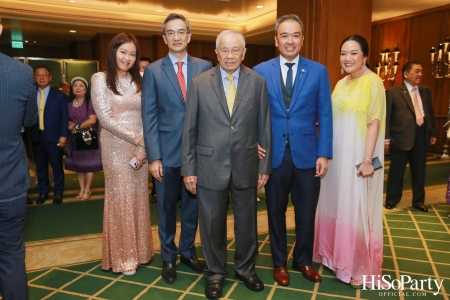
[66,77,103,201]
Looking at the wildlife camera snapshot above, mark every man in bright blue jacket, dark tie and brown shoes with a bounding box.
[254,15,333,285]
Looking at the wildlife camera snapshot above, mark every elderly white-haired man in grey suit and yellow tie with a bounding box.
[181,30,272,298]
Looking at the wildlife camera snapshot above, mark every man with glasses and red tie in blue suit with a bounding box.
[142,14,210,283]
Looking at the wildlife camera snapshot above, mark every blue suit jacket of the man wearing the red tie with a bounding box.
[142,55,211,167]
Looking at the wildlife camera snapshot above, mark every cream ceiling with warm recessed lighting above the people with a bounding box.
[0,0,450,46]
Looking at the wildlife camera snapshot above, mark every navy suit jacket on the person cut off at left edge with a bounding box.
[0,53,37,199]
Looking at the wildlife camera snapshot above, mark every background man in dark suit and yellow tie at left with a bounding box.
[31,66,69,204]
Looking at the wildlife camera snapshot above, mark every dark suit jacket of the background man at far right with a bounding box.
[385,83,436,151]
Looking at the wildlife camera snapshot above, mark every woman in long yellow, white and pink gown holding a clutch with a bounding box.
[313,35,386,288]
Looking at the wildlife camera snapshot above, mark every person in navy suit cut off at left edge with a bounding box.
[0,25,37,300]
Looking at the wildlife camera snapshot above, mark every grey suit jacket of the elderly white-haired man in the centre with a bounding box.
[181,65,272,190]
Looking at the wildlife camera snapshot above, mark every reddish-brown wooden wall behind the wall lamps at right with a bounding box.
[370,5,450,153]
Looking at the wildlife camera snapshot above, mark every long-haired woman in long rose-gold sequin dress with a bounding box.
[91,33,154,275]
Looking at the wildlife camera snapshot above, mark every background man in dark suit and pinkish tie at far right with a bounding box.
[384,61,436,212]
